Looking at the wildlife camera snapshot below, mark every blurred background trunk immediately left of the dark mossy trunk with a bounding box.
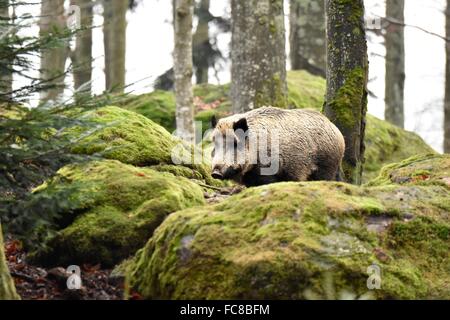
[289,0,326,77]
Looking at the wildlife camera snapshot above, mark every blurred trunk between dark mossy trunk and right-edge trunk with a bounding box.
[384,0,405,128]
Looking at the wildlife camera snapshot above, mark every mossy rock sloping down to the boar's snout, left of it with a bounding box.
[64,106,221,185]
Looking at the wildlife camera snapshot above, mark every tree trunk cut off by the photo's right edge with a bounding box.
[444,0,450,153]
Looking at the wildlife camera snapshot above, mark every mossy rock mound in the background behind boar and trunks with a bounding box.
[118,71,434,182]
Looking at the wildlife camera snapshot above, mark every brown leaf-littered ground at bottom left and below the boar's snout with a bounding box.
[5,186,244,300]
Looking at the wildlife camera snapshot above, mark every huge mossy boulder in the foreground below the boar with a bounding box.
[126,155,450,299]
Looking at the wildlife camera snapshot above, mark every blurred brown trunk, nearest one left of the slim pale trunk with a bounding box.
[103,0,128,93]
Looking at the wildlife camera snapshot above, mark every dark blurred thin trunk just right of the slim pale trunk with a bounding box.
[193,0,210,84]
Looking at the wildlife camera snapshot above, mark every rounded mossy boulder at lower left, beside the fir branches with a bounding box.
[31,160,204,266]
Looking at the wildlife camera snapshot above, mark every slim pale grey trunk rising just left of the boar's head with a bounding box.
[173,0,194,142]
